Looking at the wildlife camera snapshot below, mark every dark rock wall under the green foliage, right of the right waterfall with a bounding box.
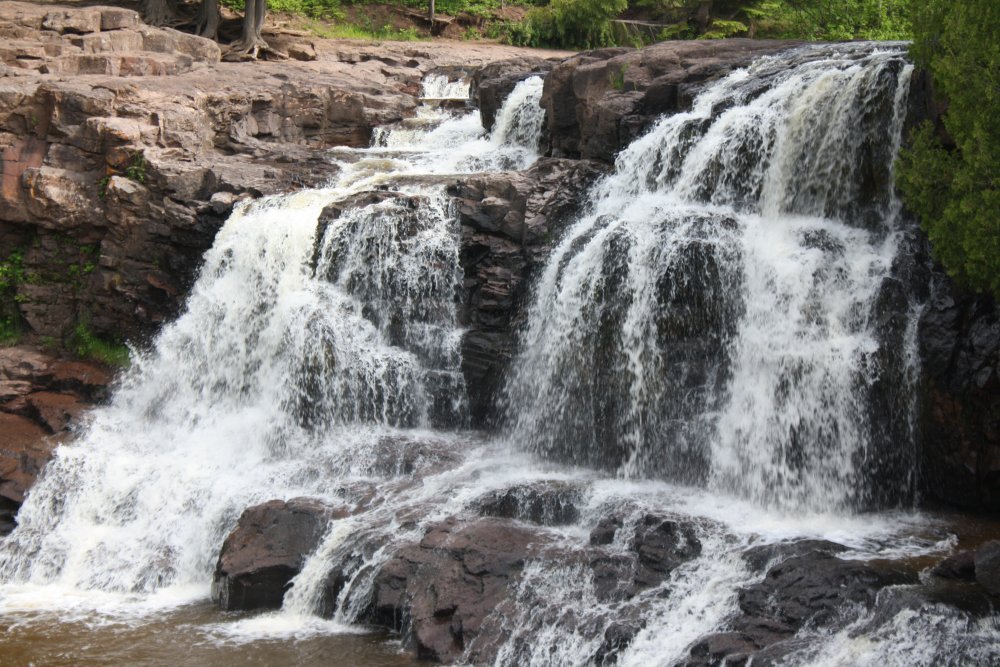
[918,274,1000,511]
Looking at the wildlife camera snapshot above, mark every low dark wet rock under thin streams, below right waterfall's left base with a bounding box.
[476,482,581,526]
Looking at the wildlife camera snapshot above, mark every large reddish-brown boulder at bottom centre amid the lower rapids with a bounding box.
[364,518,546,662]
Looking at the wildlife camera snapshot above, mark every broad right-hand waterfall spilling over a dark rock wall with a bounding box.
[506,45,912,510]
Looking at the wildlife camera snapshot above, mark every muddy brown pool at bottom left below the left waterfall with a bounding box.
[0,602,420,667]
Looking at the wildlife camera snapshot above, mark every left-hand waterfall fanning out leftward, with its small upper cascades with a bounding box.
[0,75,541,593]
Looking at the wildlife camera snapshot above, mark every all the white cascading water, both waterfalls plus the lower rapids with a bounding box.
[0,45,998,666]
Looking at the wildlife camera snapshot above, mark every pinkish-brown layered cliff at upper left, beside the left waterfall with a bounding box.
[0,2,419,339]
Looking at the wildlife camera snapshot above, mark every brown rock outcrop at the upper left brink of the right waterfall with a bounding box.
[542,39,797,162]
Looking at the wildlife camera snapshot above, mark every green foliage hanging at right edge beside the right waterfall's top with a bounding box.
[898,0,1000,296]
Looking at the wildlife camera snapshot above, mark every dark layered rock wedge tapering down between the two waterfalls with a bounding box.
[448,159,604,426]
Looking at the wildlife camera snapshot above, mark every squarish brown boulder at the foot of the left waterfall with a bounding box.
[212,498,346,611]
